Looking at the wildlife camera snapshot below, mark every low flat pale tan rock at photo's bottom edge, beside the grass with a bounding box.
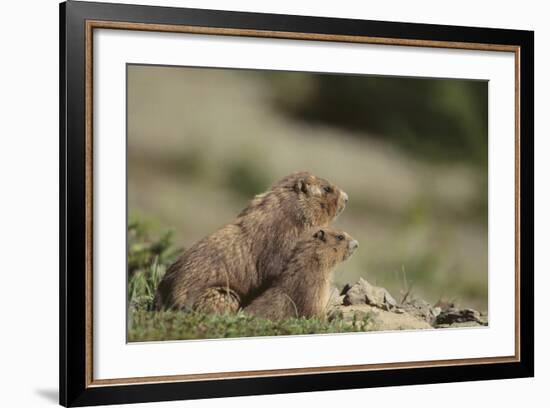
[329,304,432,331]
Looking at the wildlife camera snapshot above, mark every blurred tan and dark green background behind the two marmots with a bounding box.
[128,65,488,310]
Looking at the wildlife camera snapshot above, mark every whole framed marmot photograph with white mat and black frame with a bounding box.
[60,1,534,406]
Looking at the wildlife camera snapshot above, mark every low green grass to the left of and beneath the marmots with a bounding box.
[128,219,369,342]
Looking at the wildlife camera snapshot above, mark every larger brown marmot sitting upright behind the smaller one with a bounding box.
[155,172,348,313]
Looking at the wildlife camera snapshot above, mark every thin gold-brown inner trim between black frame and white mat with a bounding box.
[85,20,521,388]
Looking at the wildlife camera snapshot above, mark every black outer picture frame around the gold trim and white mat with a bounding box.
[59,1,534,406]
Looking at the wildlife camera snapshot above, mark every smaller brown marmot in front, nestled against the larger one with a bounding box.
[244,228,359,320]
